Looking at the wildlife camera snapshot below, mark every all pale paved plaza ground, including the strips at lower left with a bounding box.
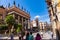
[0,32,56,40]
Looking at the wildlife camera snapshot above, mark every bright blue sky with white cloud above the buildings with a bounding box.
[0,0,50,22]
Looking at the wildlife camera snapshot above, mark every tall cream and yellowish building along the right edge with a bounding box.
[46,0,60,34]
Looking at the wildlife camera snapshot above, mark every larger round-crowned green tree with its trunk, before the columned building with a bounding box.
[5,15,15,33]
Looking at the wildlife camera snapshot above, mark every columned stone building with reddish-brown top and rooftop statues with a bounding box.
[0,3,30,29]
